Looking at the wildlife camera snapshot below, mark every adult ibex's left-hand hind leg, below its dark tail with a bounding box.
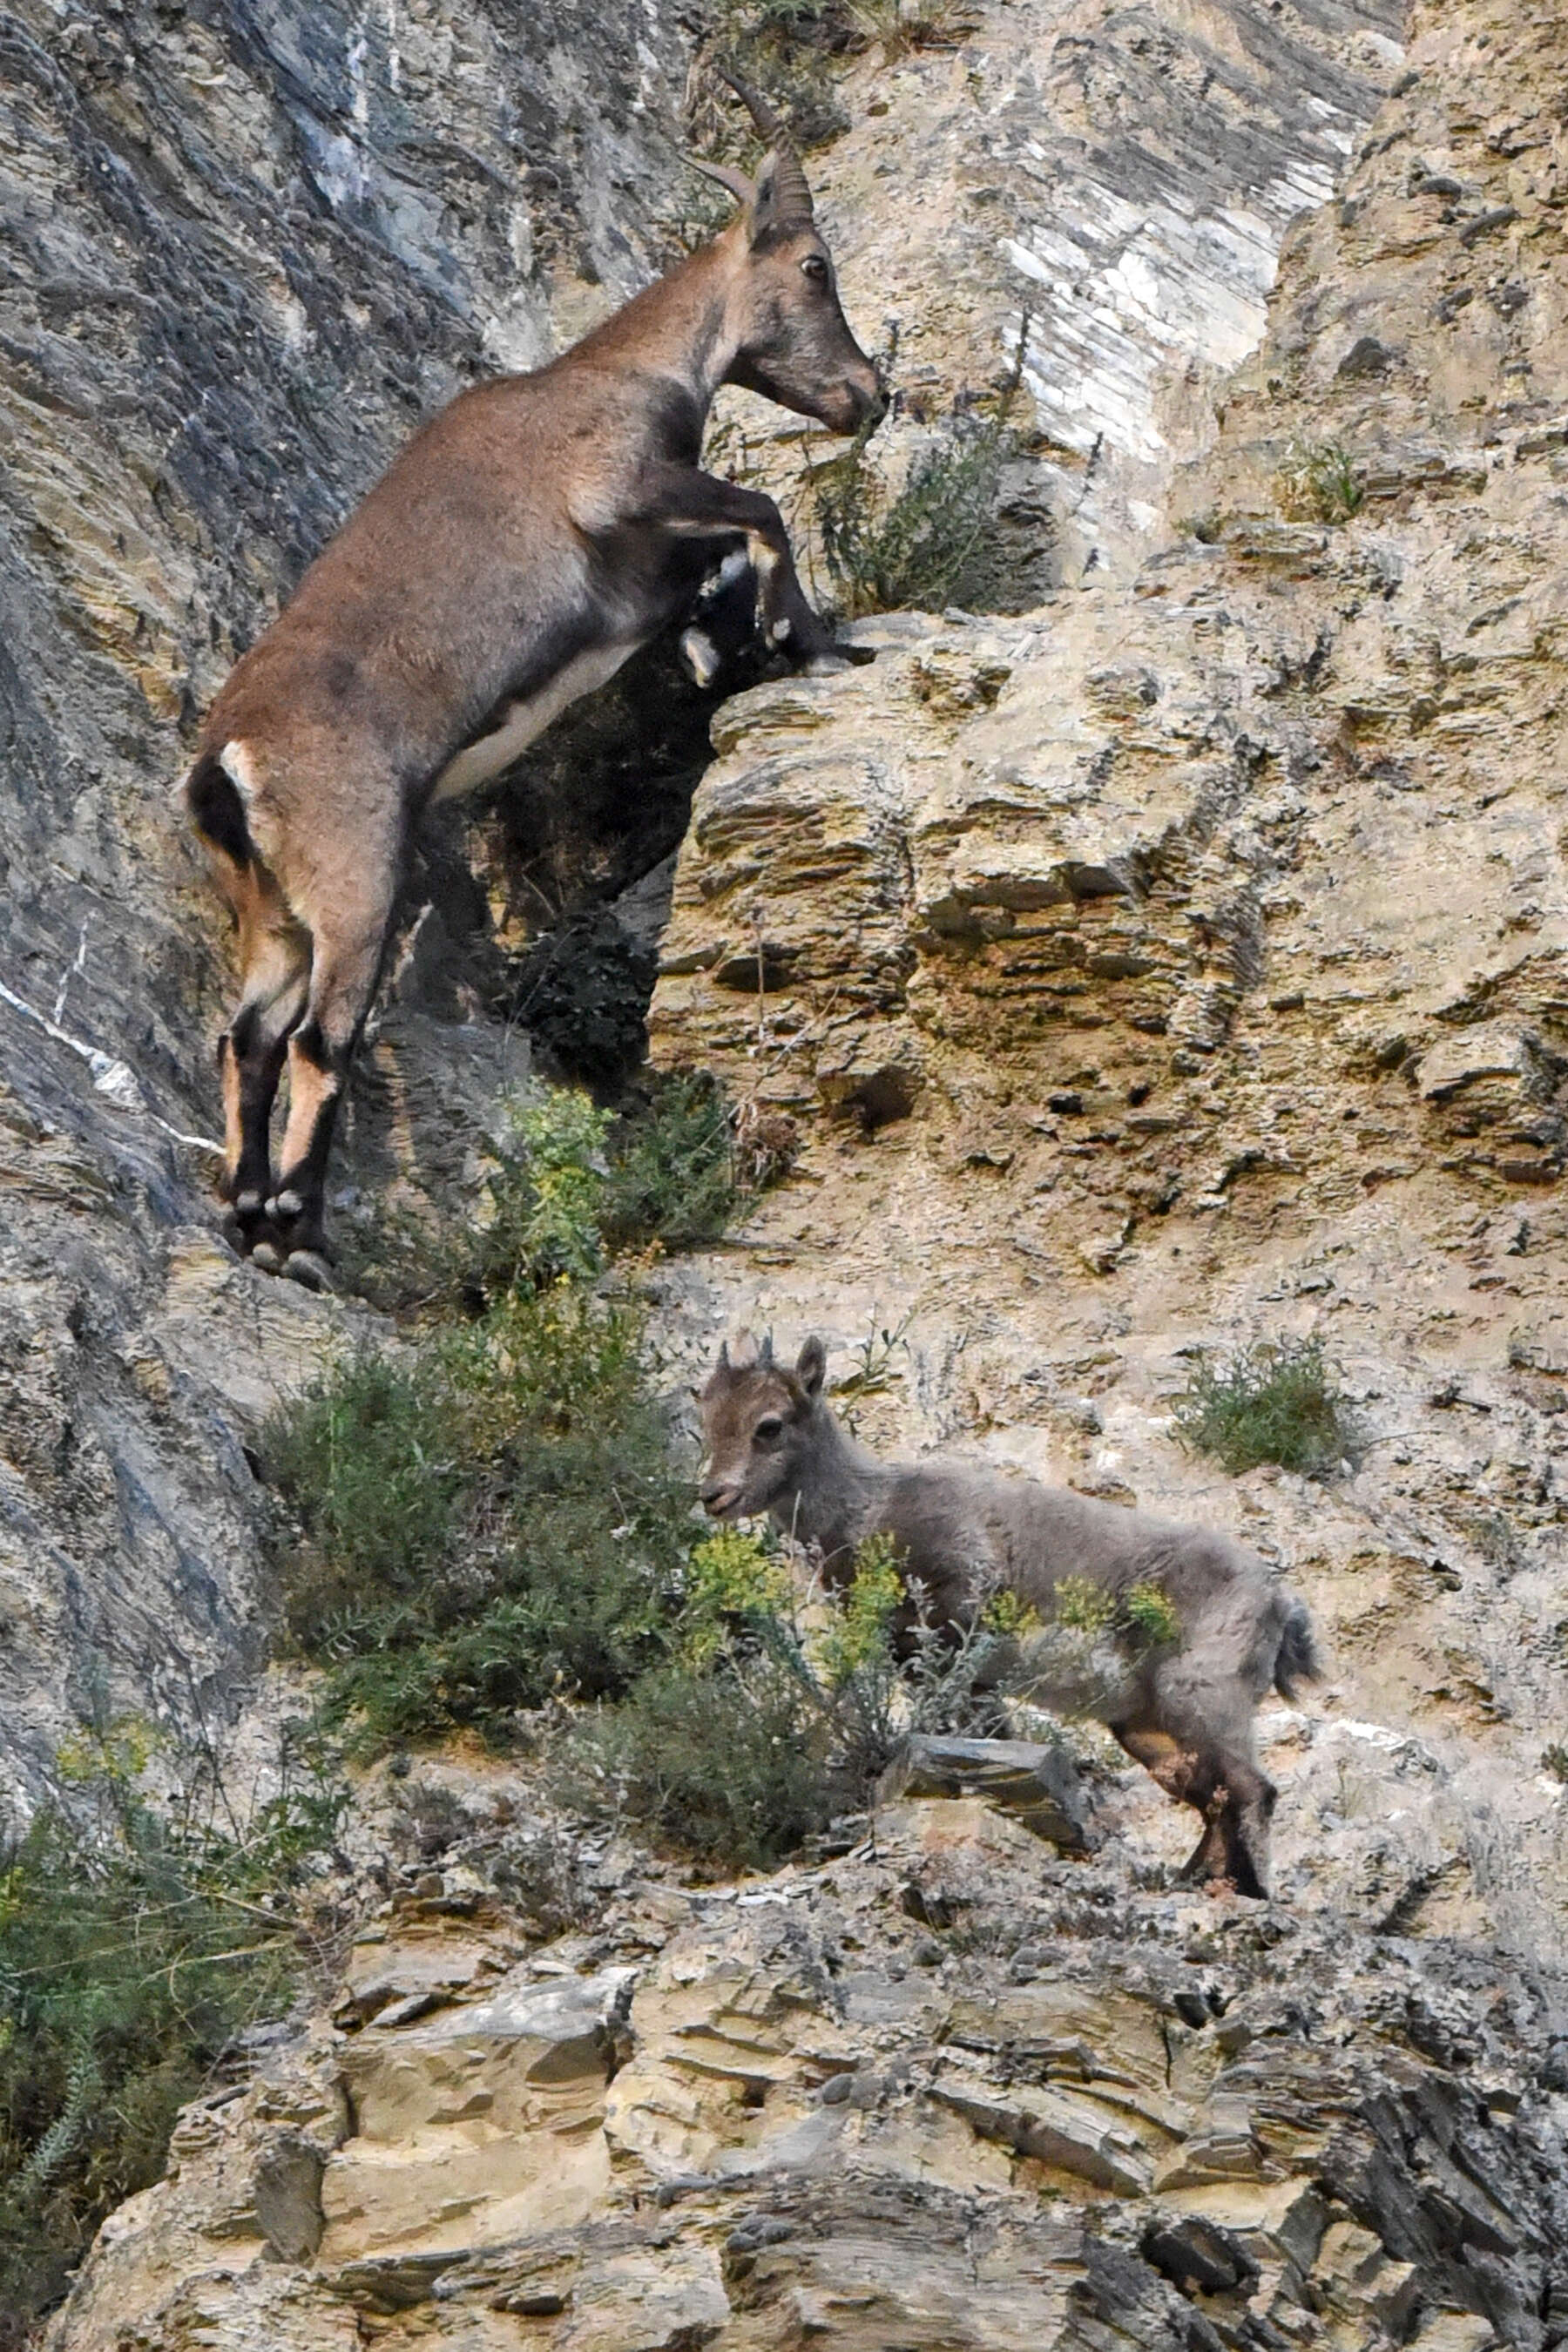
[219,861,310,1256]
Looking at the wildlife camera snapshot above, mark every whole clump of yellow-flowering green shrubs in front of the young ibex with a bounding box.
[268,1082,1020,1865]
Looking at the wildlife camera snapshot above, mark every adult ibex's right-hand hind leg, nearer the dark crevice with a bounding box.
[256,861,397,1289]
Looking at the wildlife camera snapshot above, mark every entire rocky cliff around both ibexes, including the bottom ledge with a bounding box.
[0,0,1568,2352]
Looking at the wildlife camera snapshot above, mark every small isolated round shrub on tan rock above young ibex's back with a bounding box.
[1175,1338,1356,1477]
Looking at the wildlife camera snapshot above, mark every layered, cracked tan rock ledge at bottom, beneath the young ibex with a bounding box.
[50,1797,1568,2352]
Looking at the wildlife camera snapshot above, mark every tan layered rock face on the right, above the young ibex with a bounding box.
[653,10,1568,1948]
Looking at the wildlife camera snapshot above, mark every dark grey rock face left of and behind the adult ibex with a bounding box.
[0,0,686,1783]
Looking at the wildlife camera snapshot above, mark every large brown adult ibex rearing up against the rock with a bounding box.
[181,84,884,1284]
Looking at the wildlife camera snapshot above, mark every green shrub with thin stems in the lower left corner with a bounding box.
[0,1724,343,2348]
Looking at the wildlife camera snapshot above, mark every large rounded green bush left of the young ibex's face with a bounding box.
[280,1280,691,1745]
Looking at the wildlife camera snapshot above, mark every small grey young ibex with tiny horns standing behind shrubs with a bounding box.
[703,1338,1321,1896]
